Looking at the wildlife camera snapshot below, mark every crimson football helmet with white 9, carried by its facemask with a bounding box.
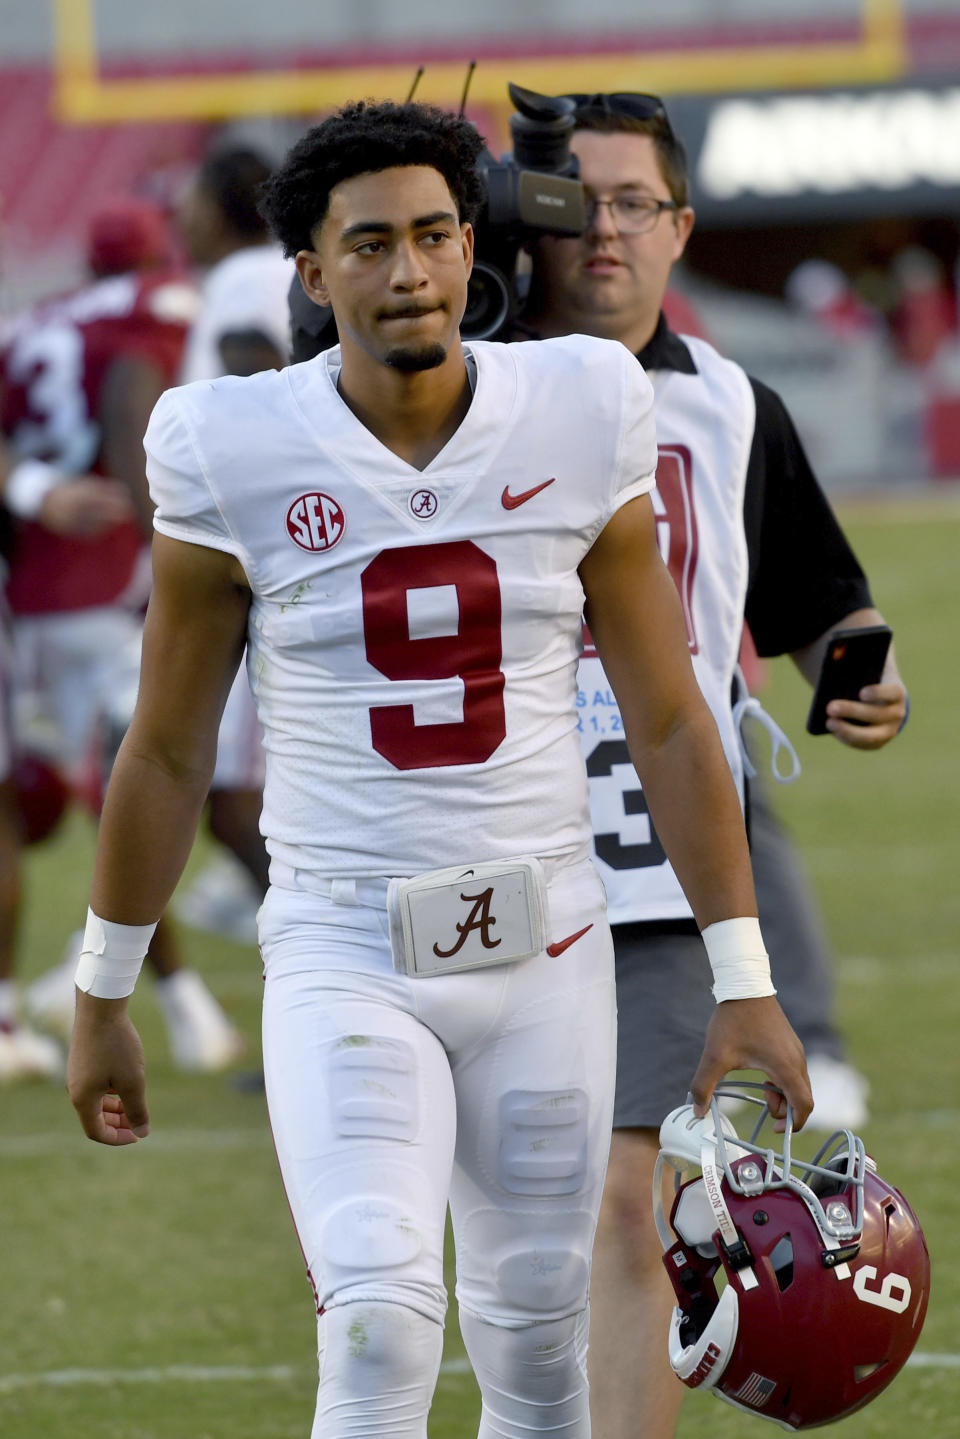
[653,1084,930,1429]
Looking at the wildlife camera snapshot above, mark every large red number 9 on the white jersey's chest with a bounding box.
[360,540,507,770]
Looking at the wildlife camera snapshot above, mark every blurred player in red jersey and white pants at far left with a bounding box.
[0,199,242,1069]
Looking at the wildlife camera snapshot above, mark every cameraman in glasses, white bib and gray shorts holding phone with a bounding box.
[522,94,907,1439]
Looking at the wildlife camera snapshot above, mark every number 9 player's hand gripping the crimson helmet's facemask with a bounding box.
[689,996,813,1131]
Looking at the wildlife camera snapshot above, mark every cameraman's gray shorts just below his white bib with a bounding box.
[613,920,717,1130]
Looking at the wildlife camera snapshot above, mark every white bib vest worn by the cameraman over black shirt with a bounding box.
[577,335,756,924]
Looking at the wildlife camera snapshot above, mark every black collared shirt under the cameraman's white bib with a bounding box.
[636,314,872,655]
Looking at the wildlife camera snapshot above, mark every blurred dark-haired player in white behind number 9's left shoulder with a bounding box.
[170,145,295,941]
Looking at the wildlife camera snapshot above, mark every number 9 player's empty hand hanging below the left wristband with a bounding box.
[66,990,150,1144]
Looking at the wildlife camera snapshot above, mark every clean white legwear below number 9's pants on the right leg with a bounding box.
[461,1305,590,1439]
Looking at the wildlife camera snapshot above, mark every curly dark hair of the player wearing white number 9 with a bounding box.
[261,101,484,256]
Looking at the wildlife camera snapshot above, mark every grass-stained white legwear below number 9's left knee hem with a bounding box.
[311,1301,443,1439]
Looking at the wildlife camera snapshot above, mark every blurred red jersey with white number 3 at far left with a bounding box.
[0,273,196,614]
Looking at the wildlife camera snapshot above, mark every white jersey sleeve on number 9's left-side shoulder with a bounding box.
[144,390,242,558]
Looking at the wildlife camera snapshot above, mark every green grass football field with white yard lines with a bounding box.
[0,494,960,1439]
